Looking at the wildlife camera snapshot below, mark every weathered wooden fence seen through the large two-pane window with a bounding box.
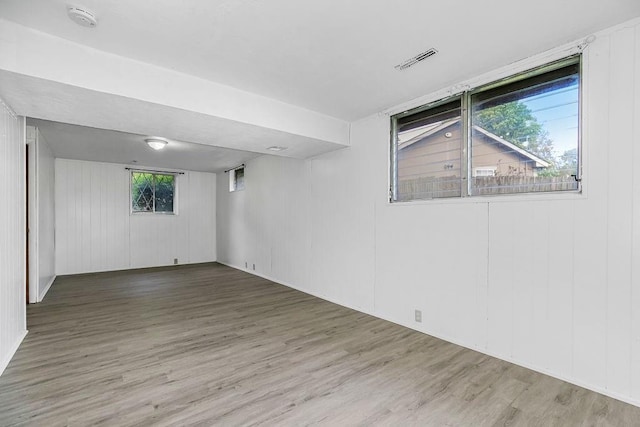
[397,176,578,201]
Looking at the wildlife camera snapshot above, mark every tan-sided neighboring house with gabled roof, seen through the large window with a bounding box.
[398,118,551,181]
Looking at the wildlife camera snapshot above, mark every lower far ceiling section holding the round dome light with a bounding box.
[27,119,260,172]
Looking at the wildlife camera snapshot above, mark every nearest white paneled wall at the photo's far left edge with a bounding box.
[0,100,27,374]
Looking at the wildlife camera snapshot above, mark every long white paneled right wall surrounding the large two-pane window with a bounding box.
[217,20,640,405]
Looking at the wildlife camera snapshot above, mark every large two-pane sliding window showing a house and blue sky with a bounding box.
[391,56,580,201]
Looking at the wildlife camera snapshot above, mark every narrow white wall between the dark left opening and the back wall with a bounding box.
[27,126,56,303]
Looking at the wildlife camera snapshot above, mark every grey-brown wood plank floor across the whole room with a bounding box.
[0,264,640,426]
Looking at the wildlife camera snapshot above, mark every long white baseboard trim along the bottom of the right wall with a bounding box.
[218,261,640,407]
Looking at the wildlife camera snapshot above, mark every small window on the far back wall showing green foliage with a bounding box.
[131,171,176,214]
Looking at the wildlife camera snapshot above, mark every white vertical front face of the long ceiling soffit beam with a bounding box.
[0,19,349,152]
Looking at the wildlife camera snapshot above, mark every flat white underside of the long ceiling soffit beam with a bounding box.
[0,70,345,159]
